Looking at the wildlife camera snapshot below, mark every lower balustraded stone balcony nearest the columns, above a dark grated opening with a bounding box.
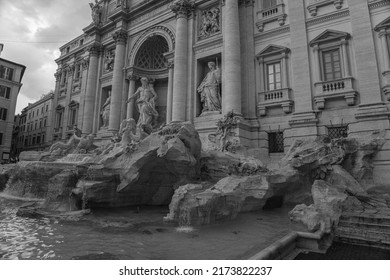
[257,88,293,116]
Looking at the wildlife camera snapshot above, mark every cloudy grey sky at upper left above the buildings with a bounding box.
[0,0,93,114]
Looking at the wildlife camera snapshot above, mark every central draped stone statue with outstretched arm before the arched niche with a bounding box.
[127,77,158,131]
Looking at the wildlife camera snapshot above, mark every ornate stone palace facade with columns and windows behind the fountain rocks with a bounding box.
[53,0,390,183]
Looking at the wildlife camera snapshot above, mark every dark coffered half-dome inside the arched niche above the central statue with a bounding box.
[135,35,169,69]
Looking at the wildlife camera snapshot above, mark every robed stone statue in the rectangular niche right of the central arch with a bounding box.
[198,61,222,113]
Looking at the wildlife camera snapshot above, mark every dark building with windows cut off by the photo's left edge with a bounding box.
[0,45,26,161]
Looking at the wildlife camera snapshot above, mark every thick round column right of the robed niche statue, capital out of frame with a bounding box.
[222,0,241,114]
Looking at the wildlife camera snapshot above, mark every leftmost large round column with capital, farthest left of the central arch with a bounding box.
[82,44,101,135]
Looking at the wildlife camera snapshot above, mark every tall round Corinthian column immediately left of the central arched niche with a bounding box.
[108,30,127,132]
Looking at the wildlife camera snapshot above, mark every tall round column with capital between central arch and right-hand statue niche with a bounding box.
[171,0,195,121]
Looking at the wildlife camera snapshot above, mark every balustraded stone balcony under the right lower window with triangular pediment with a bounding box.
[314,77,357,110]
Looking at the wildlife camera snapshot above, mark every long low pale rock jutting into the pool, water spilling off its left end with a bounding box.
[166,175,272,225]
